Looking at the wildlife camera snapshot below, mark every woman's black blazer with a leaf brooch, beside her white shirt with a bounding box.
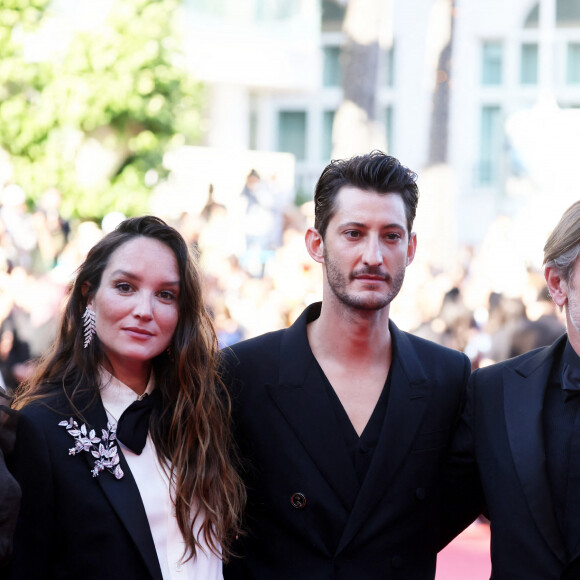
[9,396,162,580]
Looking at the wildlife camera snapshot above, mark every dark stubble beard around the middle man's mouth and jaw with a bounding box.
[324,250,405,311]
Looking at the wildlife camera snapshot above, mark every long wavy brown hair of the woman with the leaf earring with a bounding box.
[13,216,245,560]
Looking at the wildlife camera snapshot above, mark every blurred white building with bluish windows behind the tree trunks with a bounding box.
[185,0,580,254]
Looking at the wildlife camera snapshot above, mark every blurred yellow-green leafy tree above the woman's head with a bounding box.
[0,0,203,217]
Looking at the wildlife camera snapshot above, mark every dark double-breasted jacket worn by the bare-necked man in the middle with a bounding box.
[224,305,470,580]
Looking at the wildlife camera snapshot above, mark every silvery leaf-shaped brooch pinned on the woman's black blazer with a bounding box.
[58,417,124,479]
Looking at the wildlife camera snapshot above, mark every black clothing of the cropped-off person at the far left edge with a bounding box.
[0,392,20,577]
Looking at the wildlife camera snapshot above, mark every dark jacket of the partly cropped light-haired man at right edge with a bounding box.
[448,336,580,580]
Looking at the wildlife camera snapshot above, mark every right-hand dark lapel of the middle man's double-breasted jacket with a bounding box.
[338,322,433,552]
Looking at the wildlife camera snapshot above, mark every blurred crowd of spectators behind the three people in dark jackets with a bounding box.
[0,170,565,391]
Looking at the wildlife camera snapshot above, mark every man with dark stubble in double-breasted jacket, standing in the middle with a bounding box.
[224,151,470,580]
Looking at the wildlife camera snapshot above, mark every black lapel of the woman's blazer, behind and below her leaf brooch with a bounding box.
[83,398,162,580]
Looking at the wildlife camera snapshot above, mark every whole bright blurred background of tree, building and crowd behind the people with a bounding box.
[0,0,580,578]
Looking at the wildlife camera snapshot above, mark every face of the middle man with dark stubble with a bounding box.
[322,186,416,310]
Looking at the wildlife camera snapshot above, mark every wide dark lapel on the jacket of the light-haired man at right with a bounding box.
[503,343,566,561]
